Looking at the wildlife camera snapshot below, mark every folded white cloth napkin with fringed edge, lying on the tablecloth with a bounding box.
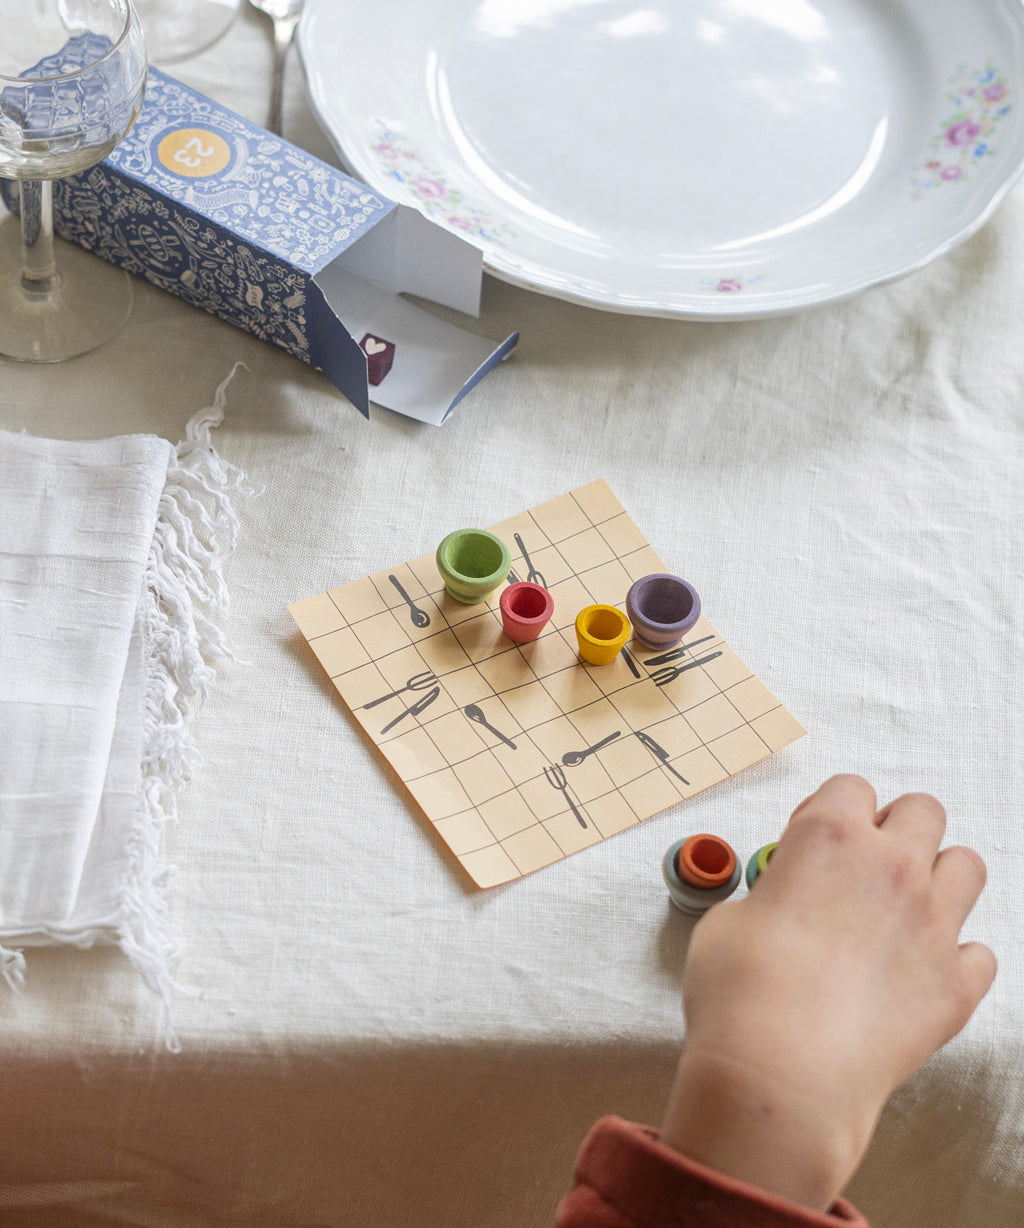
[0,377,246,1049]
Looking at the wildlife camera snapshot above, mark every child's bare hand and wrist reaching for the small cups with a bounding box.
[662,776,996,1211]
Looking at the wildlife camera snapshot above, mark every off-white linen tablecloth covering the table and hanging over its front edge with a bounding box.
[0,7,1024,1228]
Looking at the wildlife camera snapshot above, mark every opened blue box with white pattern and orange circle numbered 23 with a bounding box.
[5,69,518,425]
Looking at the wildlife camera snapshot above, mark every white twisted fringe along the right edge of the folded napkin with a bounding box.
[113,362,255,1052]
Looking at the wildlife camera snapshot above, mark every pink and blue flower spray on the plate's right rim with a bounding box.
[911,63,1009,200]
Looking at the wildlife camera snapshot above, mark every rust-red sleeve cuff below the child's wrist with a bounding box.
[556,1117,868,1228]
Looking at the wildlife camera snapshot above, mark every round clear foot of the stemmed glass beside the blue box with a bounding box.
[0,216,134,362]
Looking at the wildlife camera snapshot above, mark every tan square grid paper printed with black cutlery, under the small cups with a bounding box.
[289,480,804,887]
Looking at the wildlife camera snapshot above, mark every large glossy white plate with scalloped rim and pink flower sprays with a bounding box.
[300,0,1024,319]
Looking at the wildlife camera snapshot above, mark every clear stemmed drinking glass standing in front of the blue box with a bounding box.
[0,0,146,362]
